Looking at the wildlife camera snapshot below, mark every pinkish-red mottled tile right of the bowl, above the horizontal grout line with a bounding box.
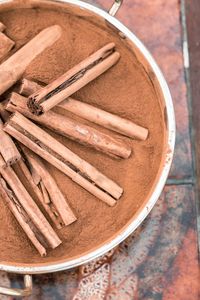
[94,0,193,179]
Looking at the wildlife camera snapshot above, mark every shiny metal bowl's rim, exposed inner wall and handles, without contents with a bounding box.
[0,0,175,296]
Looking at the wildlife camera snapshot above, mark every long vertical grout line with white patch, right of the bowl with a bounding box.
[180,0,200,250]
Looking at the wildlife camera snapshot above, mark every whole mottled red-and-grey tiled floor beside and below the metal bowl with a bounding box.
[0,0,199,300]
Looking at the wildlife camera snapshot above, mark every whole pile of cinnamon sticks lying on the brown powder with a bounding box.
[0,22,148,256]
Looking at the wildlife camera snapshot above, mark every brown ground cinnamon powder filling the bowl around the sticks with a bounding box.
[0,3,164,263]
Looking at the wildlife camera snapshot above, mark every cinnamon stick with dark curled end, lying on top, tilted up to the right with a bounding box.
[28,43,120,115]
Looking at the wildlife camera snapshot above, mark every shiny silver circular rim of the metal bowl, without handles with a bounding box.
[0,0,176,274]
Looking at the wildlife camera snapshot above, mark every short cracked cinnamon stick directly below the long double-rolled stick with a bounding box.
[22,146,77,228]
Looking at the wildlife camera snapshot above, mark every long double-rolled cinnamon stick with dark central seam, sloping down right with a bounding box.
[4,112,123,205]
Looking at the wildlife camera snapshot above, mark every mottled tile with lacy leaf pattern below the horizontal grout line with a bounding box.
[7,185,199,300]
